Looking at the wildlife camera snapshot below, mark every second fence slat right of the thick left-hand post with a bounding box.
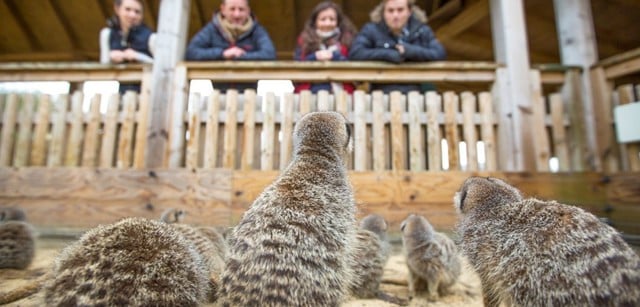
[204,90,224,168]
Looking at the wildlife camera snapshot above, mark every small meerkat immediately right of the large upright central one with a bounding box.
[351,214,391,298]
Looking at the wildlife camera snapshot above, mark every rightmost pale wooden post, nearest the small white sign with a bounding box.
[553,0,600,171]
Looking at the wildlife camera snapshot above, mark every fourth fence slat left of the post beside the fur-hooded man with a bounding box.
[426,92,442,171]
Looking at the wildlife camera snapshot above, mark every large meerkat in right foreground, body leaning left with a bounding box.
[454,177,640,306]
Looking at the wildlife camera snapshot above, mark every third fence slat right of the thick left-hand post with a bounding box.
[222,90,238,169]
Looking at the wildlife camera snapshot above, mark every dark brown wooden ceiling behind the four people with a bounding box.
[0,0,640,63]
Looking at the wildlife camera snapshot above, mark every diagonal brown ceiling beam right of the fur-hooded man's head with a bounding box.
[436,0,489,42]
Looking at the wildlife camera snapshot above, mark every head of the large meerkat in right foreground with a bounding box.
[453,177,523,214]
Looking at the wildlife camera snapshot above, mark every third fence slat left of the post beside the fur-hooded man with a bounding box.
[444,92,460,170]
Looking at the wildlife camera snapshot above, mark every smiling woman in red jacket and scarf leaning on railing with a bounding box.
[293,1,358,94]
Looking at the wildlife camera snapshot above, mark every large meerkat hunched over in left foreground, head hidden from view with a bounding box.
[44,218,209,306]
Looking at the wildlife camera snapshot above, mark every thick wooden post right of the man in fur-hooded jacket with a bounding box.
[490,0,536,171]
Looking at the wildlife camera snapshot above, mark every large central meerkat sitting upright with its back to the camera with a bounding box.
[215,112,357,306]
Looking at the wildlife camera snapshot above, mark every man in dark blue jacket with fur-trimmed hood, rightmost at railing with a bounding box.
[349,0,447,93]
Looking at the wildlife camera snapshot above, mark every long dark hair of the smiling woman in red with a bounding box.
[300,1,357,54]
